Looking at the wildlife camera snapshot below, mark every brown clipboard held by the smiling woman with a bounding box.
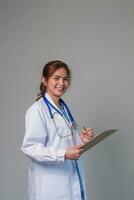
[81,129,118,153]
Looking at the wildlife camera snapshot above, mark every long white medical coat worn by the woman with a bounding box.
[21,94,84,200]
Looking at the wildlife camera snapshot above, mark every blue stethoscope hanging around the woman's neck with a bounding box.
[43,96,77,138]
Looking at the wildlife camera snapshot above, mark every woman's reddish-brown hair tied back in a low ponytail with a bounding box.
[36,60,71,101]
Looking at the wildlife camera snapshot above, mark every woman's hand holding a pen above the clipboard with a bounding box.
[80,128,94,144]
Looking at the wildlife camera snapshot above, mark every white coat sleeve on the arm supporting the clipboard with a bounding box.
[21,105,66,163]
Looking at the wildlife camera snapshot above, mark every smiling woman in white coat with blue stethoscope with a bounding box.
[21,60,93,200]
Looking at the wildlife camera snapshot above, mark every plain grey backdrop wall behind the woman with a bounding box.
[0,0,134,200]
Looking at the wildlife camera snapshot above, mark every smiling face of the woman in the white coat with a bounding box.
[43,68,70,98]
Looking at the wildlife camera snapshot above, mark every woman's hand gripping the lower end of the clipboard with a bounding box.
[65,145,83,160]
